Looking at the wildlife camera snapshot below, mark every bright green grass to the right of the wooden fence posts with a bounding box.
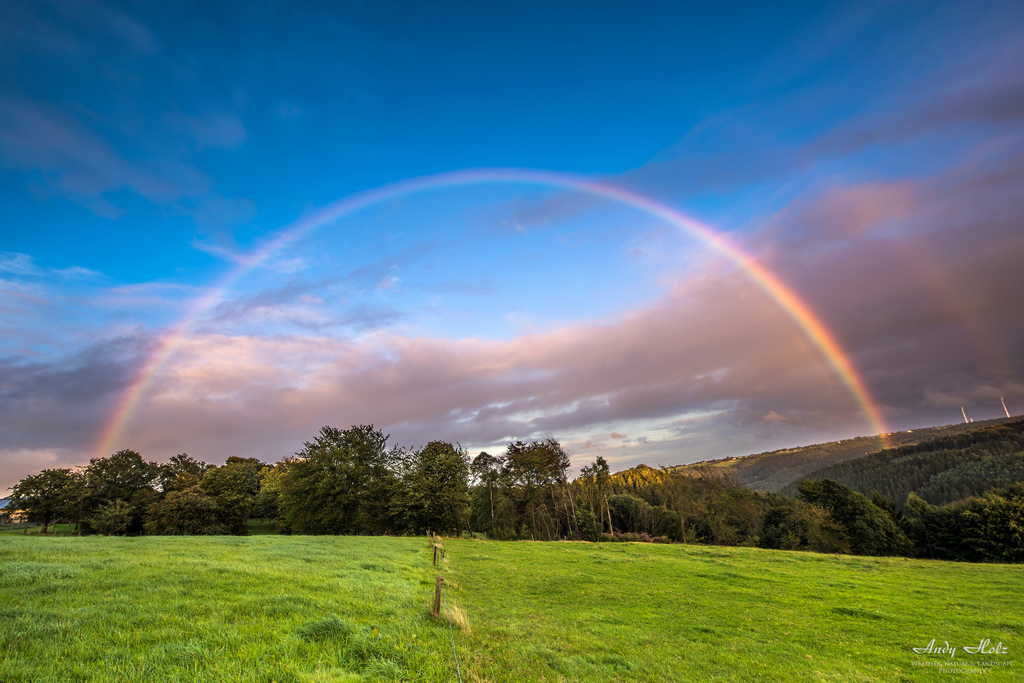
[445,541,1024,681]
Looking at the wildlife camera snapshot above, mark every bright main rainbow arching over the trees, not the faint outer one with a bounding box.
[94,168,889,457]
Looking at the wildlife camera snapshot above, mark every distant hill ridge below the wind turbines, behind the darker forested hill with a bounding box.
[671,417,1021,491]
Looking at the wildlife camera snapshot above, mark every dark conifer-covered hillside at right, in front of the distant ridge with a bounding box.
[783,419,1024,509]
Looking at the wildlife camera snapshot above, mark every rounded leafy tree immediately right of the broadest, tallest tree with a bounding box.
[395,441,469,535]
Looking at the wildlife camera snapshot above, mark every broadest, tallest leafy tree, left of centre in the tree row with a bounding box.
[278,425,400,533]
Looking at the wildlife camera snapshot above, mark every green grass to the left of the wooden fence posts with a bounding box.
[0,536,452,683]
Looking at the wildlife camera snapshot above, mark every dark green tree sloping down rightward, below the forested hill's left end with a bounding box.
[799,479,913,556]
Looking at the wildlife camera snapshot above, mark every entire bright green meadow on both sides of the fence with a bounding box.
[0,536,1024,682]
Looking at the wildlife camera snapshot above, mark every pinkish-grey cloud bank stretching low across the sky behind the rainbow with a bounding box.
[8,140,1024,485]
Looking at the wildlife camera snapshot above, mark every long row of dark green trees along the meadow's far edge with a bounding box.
[8,425,1024,561]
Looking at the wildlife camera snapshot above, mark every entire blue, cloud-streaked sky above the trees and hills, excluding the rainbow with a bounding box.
[0,1,1024,485]
